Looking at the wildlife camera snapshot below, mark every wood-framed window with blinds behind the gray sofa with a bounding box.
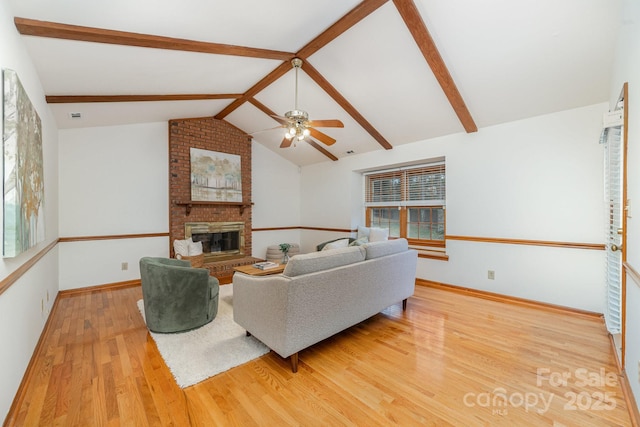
[365,162,446,246]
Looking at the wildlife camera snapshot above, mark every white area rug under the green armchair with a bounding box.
[138,285,269,388]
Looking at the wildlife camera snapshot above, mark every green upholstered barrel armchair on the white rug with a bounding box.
[140,257,220,333]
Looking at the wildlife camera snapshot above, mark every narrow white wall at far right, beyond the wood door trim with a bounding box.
[610,0,640,412]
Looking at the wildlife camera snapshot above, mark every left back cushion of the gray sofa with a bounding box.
[283,246,365,277]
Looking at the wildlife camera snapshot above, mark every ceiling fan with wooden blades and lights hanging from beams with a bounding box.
[271,58,344,148]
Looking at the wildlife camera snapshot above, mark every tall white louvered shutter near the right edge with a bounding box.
[602,126,623,334]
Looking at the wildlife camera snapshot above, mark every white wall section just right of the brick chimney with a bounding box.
[251,142,300,258]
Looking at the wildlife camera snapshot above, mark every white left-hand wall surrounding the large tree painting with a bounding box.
[0,1,58,420]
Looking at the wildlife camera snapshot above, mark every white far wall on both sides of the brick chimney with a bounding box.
[59,126,300,289]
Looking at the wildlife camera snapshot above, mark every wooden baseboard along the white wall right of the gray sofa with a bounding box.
[416,279,604,322]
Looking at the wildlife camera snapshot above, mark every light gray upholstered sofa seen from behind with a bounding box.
[233,239,417,372]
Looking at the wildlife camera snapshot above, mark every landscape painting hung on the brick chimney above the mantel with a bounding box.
[189,148,242,202]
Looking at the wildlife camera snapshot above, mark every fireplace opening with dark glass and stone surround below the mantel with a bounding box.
[184,222,244,262]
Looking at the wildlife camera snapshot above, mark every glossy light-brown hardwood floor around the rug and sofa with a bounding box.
[5,286,631,426]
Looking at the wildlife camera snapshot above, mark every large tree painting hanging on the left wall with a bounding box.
[2,69,44,257]
